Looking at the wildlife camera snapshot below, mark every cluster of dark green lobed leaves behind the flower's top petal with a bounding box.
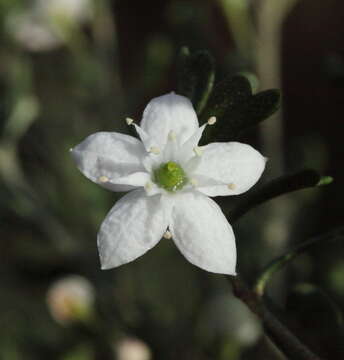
[178,47,281,141]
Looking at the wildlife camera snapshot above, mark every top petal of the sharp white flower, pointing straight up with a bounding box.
[141,93,198,147]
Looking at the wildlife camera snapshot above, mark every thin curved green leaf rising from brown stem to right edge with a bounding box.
[255,227,344,296]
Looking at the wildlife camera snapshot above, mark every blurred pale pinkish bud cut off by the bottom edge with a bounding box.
[115,337,152,360]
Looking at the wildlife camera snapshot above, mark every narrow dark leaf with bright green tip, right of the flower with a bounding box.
[228,170,330,222]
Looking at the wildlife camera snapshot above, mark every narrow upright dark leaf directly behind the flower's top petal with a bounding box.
[178,47,215,114]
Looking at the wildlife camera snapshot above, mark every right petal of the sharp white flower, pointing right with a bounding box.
[194,142,266,196]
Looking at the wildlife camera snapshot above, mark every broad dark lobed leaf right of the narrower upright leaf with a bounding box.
[202,75,280,141]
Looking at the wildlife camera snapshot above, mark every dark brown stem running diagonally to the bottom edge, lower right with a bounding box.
[226,276,321,360]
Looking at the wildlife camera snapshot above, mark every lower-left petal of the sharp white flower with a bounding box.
[98,189,169,269]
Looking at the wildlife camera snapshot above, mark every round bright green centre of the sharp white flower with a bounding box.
[154,161,188,192]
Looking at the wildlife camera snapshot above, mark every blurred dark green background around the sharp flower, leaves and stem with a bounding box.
[0,0,344,360]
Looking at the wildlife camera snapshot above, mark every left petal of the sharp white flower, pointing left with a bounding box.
[71,132,145,191]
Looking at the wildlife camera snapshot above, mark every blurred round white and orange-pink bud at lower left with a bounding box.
[47,275,95,325]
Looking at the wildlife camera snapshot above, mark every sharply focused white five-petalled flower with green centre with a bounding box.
[72,93,265,275]
